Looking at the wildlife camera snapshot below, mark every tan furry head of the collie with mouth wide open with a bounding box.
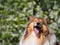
[25,17,48,37]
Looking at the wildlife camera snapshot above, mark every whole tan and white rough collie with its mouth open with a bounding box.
[19,16,56,45]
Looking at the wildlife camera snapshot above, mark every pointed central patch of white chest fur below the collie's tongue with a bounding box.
[23,32,38,45]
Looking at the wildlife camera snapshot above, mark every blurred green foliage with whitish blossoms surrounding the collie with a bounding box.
[0,0,60,45]
